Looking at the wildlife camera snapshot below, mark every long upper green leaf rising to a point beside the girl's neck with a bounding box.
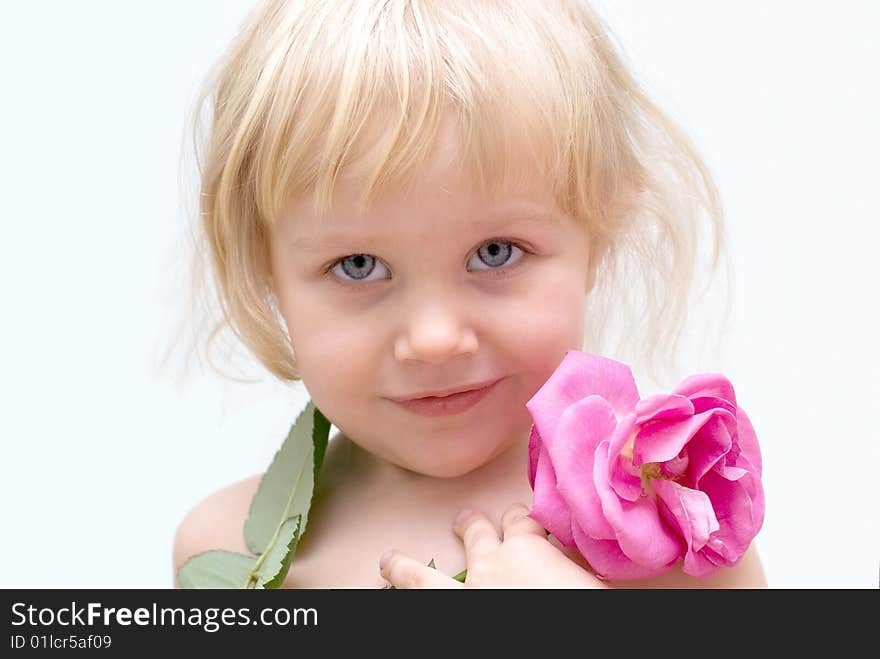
[244,401,330,558]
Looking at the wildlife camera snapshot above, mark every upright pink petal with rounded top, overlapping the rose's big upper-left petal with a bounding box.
[544,396,617,538]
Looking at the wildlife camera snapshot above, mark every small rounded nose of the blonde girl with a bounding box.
[394,297,477,364]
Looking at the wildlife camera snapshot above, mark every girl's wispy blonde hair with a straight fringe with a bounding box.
[170,0,724,390]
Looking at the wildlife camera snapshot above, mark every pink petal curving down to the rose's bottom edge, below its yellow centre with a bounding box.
[596,440,684,569]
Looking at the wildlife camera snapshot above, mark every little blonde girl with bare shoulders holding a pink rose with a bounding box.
[174,0,765,588]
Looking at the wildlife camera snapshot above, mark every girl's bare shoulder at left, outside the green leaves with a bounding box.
[172,474,262,588]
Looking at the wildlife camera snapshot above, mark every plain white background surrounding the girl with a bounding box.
[0,0,880,588]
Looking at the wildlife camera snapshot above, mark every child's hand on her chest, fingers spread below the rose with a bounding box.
[379,504,607,588]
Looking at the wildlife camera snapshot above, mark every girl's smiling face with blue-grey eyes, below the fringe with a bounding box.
[270,120,594,477]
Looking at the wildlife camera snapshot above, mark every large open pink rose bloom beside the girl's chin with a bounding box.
[526,350,764,579]
